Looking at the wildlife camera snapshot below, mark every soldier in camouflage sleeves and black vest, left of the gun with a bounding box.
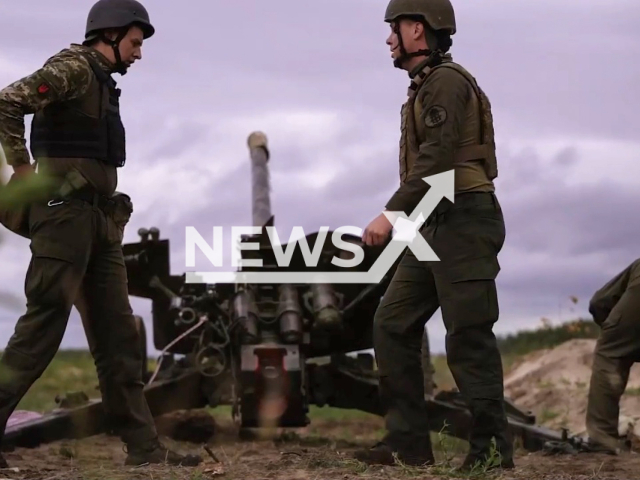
[0,0,201,467]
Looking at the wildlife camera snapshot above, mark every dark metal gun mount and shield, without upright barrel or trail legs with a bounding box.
[124,216,388,428]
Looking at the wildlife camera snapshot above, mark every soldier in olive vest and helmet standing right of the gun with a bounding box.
[356,0,513,470]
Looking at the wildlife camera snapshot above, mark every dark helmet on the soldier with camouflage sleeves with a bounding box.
[85,0,155,39]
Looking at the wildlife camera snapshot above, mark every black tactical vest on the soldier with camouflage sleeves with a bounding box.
[30,53,126,167]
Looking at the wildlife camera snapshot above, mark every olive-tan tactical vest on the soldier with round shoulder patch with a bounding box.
[400,61,498,190]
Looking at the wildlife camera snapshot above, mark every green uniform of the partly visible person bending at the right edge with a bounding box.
[586,259,640,452]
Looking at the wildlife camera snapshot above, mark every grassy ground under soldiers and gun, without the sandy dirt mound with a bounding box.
[0,321,640,480]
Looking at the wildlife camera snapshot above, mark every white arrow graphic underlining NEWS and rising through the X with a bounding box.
[185,170,454,284]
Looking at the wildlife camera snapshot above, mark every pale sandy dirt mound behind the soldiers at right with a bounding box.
[505,339,640,436]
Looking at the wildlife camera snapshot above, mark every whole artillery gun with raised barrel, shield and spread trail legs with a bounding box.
[3,133,588,458]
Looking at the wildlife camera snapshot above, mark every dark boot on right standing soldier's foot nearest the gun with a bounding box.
[354,435,435,466]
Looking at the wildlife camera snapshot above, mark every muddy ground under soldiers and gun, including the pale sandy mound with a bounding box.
[5,340,640,480]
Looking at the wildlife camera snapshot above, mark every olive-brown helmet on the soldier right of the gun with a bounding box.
[384,0,456,35]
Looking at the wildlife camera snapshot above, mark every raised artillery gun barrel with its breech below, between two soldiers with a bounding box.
[232,132,308,427]
